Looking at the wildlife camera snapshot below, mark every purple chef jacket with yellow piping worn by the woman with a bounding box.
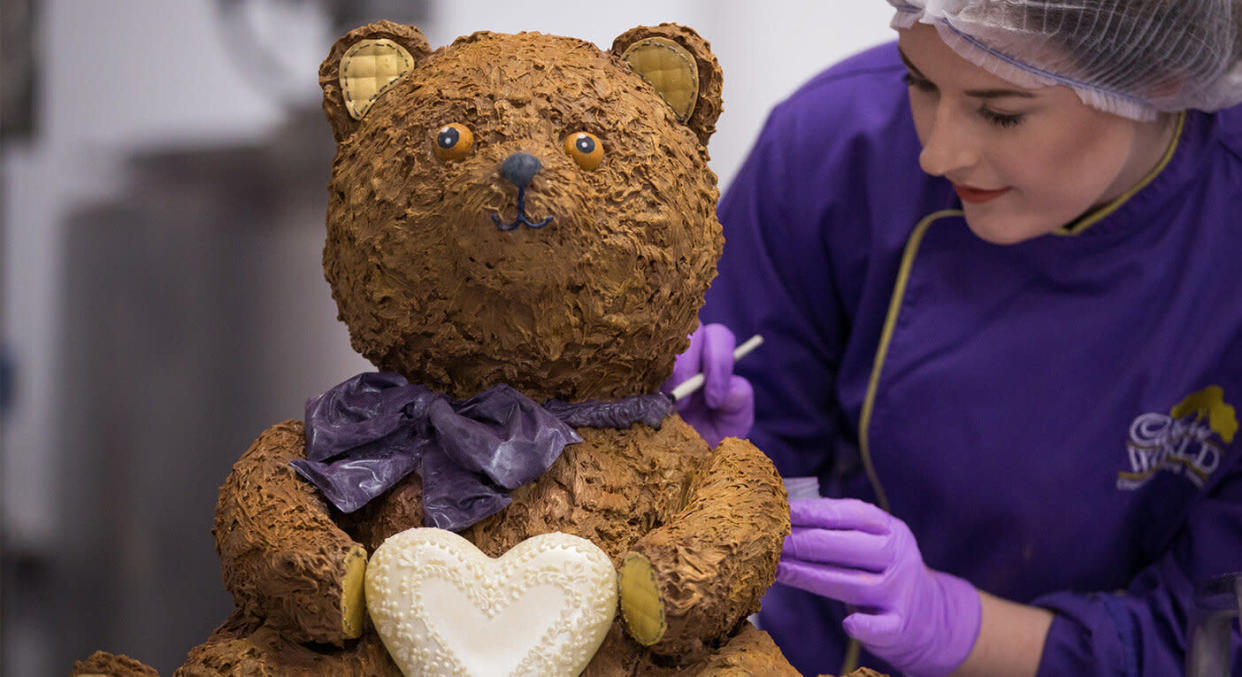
[700,43,1242,676]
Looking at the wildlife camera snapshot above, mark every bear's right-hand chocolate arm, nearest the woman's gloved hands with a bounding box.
[621,437,789,657]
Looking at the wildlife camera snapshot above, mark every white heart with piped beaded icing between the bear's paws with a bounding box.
[366,528,617,677]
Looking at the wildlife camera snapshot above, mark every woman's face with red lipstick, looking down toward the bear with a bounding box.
[898,24,1171,245]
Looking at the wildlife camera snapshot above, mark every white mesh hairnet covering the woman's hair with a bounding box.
[888,0,1242,119]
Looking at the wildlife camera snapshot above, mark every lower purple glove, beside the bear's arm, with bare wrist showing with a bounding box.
[776,498,982,676]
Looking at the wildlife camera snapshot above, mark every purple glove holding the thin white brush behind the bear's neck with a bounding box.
[661,324,755,447]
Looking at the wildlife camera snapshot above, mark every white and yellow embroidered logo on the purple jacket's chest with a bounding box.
[1117,385,1238,489]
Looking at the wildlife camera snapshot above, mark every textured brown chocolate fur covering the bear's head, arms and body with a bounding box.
[179,22,796,675]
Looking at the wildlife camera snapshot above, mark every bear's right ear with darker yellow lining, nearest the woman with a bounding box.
[612,24,722,145]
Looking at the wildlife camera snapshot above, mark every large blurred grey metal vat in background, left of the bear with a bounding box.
[56,108,361,675]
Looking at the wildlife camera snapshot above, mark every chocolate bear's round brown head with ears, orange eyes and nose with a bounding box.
[319,21,723,401]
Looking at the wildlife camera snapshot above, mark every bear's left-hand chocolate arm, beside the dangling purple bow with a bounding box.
[212,421,366,645]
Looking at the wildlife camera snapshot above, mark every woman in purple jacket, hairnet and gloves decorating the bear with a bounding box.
[673,0,1242,676]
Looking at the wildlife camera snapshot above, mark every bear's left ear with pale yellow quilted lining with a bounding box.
[319,21,431,143]
